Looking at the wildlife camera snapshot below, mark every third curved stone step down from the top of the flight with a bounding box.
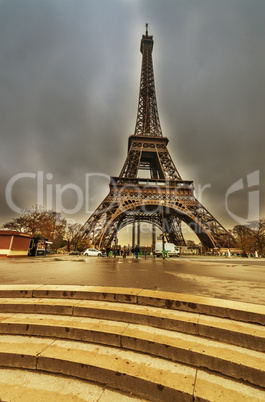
[0,313,265,387]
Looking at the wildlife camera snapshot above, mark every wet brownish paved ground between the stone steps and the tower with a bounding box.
[0,256,265,304]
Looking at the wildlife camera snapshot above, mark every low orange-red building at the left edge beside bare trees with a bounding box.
[0,230,33,257]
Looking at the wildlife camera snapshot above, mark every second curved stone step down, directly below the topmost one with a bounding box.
[0,298,265,352]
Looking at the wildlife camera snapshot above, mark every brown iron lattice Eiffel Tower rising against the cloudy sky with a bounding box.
[81,24,231,249]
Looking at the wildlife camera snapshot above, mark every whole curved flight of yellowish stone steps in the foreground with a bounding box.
[0,285,265,402]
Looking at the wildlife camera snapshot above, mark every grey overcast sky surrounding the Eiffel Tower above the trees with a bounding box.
[0,0,265,242]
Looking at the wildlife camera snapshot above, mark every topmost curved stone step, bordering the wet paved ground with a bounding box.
[0,285,265,325]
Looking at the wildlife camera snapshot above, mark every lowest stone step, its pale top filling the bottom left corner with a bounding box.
[0,368,147,402]
